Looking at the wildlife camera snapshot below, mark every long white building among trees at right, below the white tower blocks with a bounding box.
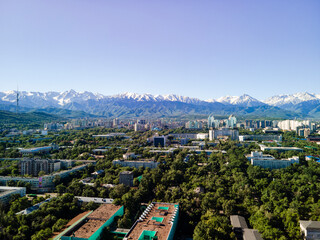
[246,152,299,169]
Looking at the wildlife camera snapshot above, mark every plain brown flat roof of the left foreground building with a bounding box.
[73,204,121,238]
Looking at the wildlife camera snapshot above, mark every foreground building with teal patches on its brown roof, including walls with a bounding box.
[123,202,179,240]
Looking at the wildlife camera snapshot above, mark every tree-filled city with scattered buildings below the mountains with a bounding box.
[0,113,320,240]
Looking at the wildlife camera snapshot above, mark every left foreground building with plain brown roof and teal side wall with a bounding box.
[59,204,124,240]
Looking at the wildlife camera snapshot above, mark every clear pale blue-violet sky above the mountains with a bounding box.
[0,0,320,99]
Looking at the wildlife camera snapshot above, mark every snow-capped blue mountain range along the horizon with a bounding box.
[0,90,320,116]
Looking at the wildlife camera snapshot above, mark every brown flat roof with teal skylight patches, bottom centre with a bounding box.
[126,203,178,240]
